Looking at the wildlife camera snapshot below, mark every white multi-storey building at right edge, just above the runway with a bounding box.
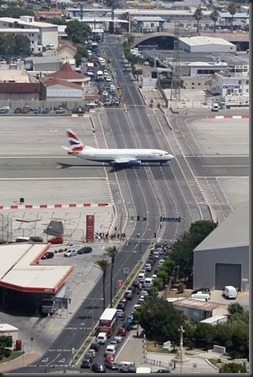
[209,64,249,106]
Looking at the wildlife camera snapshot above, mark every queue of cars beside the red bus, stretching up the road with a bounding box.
[80,245,169,373]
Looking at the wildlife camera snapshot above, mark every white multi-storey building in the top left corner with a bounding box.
[0,16,58,54]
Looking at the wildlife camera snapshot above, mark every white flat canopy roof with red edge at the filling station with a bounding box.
[0,243,73,293]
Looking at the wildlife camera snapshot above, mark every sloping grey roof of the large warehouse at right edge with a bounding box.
[194,202,250,252]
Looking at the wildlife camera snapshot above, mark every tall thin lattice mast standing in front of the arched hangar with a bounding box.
[170,23,181,100]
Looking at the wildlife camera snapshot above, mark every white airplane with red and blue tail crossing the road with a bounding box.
[62,129,174,167]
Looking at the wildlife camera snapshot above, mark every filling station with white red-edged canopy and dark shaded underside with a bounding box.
[0,243,73,315]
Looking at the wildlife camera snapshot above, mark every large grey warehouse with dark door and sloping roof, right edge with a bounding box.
[193,203,249,291]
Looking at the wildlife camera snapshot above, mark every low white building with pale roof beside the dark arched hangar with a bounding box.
[179,36,236,53]
